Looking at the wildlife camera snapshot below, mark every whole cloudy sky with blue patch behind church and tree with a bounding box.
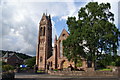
[0,0,120,56]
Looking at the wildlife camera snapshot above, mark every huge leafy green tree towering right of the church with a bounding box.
[63,2,120,68]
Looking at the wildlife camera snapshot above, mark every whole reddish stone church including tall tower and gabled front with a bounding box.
[36,14,87,70]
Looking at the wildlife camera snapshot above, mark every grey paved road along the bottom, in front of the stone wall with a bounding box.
[15,73,120,80]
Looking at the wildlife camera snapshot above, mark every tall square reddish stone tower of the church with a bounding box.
[36,13,52,70]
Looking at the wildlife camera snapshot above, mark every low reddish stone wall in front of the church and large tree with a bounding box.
[49,71,118,77]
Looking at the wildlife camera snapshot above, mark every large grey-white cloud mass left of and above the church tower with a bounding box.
[0,0,77,55]
